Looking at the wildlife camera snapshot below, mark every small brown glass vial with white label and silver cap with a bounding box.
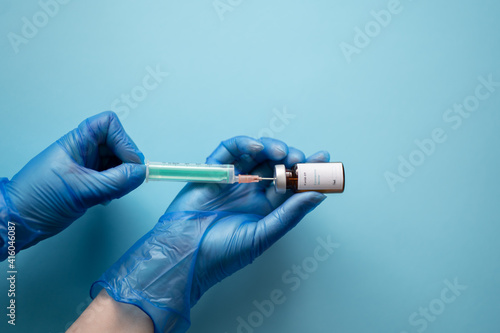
[274,162,344,193]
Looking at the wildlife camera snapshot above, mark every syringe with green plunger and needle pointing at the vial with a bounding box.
[146,162,274,184]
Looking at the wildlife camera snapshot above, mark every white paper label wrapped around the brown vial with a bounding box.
[297,163,344,191]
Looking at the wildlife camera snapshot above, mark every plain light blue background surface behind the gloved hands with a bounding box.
[0,0,500,333]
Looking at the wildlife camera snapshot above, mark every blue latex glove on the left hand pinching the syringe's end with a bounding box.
[0,112,146,260]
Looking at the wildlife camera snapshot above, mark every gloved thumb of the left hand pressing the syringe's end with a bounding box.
[80,163,146,208]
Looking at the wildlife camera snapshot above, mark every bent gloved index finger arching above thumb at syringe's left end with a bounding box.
[78,111,144,167]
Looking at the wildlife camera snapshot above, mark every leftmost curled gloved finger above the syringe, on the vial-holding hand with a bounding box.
[206,136,264,164]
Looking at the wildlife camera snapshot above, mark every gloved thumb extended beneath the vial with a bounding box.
[254,192,326,255]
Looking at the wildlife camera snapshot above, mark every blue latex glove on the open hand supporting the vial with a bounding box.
[91,137,329,332]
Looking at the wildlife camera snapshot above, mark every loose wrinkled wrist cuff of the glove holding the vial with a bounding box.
[90,212,242,332]
